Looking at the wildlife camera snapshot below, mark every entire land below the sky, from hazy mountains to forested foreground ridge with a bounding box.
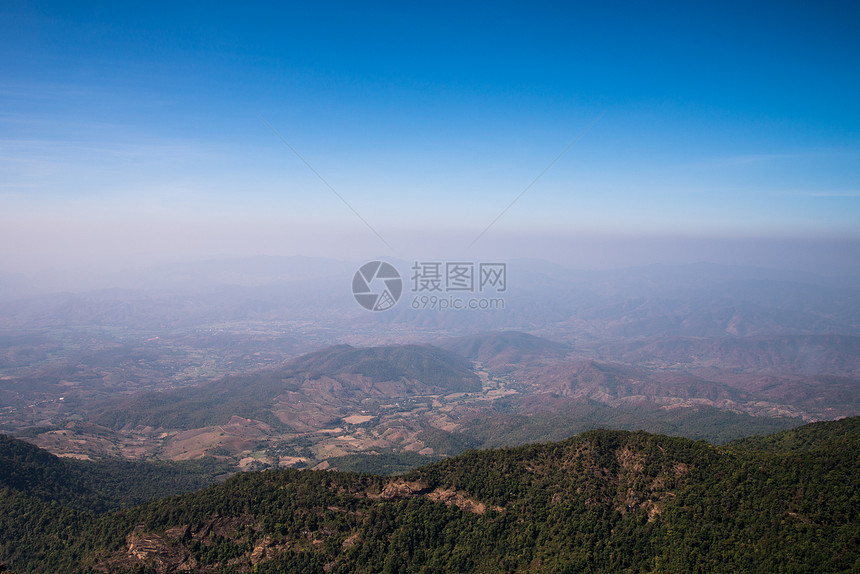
[0,257,860,572]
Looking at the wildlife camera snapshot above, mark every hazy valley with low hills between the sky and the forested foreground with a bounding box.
[0,260,860,471]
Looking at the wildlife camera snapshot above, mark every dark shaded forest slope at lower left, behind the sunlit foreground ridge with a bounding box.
[0,435,232,572]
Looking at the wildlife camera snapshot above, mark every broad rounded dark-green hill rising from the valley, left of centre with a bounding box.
[90,345,481,430]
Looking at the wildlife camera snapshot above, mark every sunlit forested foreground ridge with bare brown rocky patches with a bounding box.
[0,418,860,572]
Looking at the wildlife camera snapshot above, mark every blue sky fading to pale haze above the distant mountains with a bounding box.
[0,0,860,280]
